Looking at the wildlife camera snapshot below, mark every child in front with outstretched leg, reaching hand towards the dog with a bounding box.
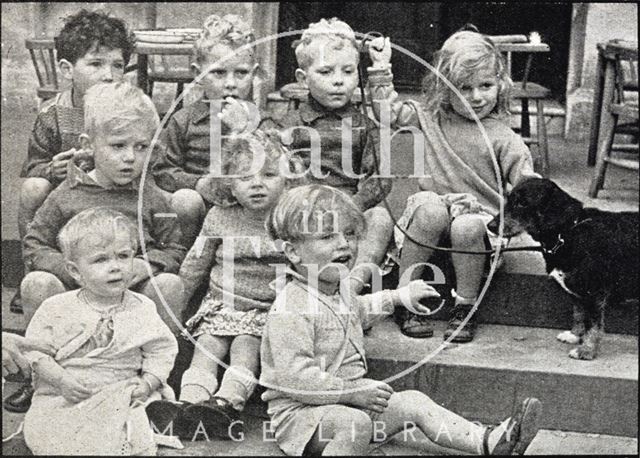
[260,185,540,456]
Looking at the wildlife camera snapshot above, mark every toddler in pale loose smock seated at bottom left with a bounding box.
[24,207,178,455]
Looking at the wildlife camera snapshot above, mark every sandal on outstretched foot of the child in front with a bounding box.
[482,398,542,455]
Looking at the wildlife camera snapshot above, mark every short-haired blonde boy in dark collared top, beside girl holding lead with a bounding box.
[262,18,393,292]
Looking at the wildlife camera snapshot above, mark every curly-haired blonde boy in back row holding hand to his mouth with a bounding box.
[153,14,258,246]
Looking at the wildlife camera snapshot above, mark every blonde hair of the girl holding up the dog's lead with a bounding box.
[423,30,513,116]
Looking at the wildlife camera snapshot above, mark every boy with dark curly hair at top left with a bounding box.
[18,10,133,239]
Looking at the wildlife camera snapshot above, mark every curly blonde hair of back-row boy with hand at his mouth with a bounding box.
[193,14,255,63]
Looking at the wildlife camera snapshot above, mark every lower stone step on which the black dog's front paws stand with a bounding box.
[366,320,638,436]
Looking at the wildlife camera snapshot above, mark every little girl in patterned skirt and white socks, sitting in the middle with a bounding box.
[149,130,301,439]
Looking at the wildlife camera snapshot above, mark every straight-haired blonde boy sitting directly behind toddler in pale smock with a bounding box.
[5,83,186,410]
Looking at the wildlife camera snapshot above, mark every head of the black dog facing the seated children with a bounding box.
[489,178,582,240]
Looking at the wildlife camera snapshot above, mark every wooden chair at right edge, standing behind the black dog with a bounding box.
[589,40,639,197]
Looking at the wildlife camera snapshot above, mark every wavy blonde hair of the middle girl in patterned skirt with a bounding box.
[211,130,306,207]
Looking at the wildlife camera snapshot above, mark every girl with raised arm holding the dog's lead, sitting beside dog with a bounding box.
[369,31,538,342]
